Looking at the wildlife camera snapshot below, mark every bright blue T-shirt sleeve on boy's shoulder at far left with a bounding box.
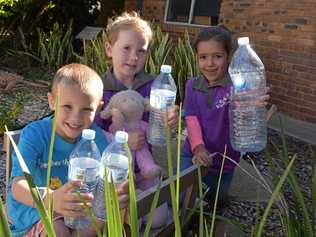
[11,126,43,177]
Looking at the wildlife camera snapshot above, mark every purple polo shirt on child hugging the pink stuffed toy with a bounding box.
[95,69,156,131]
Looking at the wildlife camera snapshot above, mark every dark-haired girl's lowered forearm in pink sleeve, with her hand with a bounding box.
[185,116,212,166]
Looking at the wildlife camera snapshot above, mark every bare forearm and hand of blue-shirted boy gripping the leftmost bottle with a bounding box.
[12,176,93,217]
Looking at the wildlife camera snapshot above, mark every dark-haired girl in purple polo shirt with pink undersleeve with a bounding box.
[181,26,269,205]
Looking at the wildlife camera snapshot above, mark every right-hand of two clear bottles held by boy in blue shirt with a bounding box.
[93,131,128,220]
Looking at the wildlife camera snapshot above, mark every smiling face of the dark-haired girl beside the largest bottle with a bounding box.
[197,39,228,84]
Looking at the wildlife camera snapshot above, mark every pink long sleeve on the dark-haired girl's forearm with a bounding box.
[185,116,204,151]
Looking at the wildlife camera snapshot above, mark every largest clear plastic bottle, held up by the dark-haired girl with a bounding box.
[228,37,267,153]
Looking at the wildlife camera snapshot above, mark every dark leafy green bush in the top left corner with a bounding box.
[0,0,99,50]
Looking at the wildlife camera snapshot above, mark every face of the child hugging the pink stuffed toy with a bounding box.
[106,29,149,81]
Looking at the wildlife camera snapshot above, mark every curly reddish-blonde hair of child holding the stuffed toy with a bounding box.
[106,11,153,45]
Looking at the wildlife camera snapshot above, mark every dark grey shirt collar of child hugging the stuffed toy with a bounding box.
[102,68,155,91]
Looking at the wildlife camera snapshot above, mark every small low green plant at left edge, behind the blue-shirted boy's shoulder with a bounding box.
[0,93,24,135]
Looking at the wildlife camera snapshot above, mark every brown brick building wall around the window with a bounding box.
[125,0,316,123]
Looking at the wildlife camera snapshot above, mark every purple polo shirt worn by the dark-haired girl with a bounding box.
[182,76,240,172]
